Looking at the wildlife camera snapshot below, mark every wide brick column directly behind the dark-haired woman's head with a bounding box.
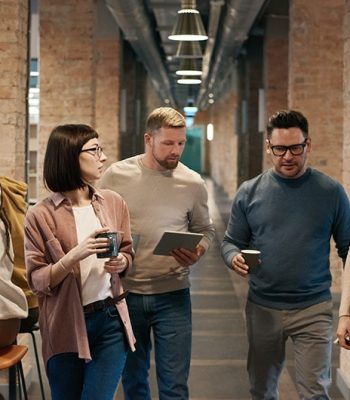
[39,0,97,195]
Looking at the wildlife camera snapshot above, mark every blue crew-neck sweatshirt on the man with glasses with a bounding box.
[221,168,350,309]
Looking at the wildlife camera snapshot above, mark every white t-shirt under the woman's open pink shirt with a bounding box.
[73,204,113,306]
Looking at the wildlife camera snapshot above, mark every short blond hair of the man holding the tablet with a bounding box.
[146,107,186,134]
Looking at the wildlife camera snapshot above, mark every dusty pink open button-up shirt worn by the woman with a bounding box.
[25,188,135,365]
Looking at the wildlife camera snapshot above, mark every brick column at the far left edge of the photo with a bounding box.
[0,0,28,180]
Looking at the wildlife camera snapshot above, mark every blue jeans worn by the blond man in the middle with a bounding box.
[123,289,192,400]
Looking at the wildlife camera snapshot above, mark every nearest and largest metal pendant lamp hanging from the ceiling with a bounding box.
[169,0,208,41]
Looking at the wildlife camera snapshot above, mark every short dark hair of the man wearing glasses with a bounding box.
[267,110,309,139]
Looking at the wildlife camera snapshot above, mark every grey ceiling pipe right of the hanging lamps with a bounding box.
[197,0,265,108]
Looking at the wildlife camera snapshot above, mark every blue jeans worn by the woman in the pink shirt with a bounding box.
[47,306,127,400]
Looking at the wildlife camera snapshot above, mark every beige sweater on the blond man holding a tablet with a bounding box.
[100,155,214,294]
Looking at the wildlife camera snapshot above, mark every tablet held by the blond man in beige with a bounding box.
[153,231,203,256]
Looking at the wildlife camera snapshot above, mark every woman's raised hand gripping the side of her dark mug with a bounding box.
[68,227,110,262]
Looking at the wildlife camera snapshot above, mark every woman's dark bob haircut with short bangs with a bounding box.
[43,124,98,192]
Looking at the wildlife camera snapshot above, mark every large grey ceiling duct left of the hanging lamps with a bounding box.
[106,0,176,106]
